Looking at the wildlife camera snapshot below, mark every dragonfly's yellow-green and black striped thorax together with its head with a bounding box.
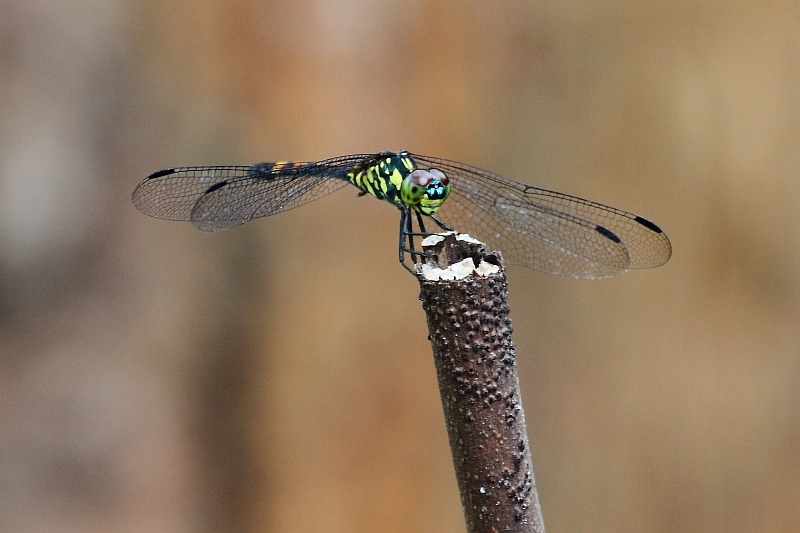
[347,150,450,215]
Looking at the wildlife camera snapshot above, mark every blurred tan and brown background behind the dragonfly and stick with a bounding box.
[0,0,800,533]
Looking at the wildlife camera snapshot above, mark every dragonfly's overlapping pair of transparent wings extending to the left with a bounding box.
[132,155,374,231]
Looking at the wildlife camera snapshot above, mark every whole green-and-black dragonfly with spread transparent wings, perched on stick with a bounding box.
[132,150,672,279]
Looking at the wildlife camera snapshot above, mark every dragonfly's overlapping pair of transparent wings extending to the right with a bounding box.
[413,154,672,278]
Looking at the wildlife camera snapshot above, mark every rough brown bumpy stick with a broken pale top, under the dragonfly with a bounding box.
[417,233,544,533]
